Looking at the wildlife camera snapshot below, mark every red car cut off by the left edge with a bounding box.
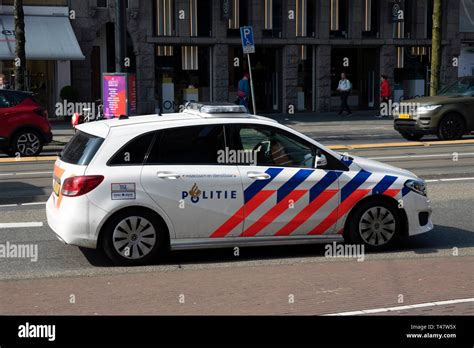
[0,89,53,157]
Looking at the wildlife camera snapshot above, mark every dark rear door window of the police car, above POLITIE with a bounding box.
[147,125,225,164]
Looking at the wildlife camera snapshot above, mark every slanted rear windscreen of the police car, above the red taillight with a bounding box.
[60,132,104,166]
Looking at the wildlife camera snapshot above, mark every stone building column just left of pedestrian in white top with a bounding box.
[315,45,331,112]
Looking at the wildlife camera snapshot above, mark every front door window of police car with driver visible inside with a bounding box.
[236,125,315,168]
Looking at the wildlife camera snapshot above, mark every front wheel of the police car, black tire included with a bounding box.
[347,200,403,251]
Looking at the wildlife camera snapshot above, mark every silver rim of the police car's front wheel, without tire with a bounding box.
[359,207,396,246]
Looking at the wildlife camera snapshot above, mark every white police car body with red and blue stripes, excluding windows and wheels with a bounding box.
[46,106,433,260]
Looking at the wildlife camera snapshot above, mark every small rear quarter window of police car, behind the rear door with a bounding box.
[108,132,156,166]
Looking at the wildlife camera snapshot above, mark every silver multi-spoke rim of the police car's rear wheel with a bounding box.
[112,216,156,260]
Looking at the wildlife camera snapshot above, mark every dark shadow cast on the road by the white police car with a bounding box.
[81,225,474,267]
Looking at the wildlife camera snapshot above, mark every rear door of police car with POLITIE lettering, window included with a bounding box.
[141,125,243,242]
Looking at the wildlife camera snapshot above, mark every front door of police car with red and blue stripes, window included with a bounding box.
[231,124,340,238]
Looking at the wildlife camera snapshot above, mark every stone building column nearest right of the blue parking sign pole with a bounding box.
[282,45,298,113]
